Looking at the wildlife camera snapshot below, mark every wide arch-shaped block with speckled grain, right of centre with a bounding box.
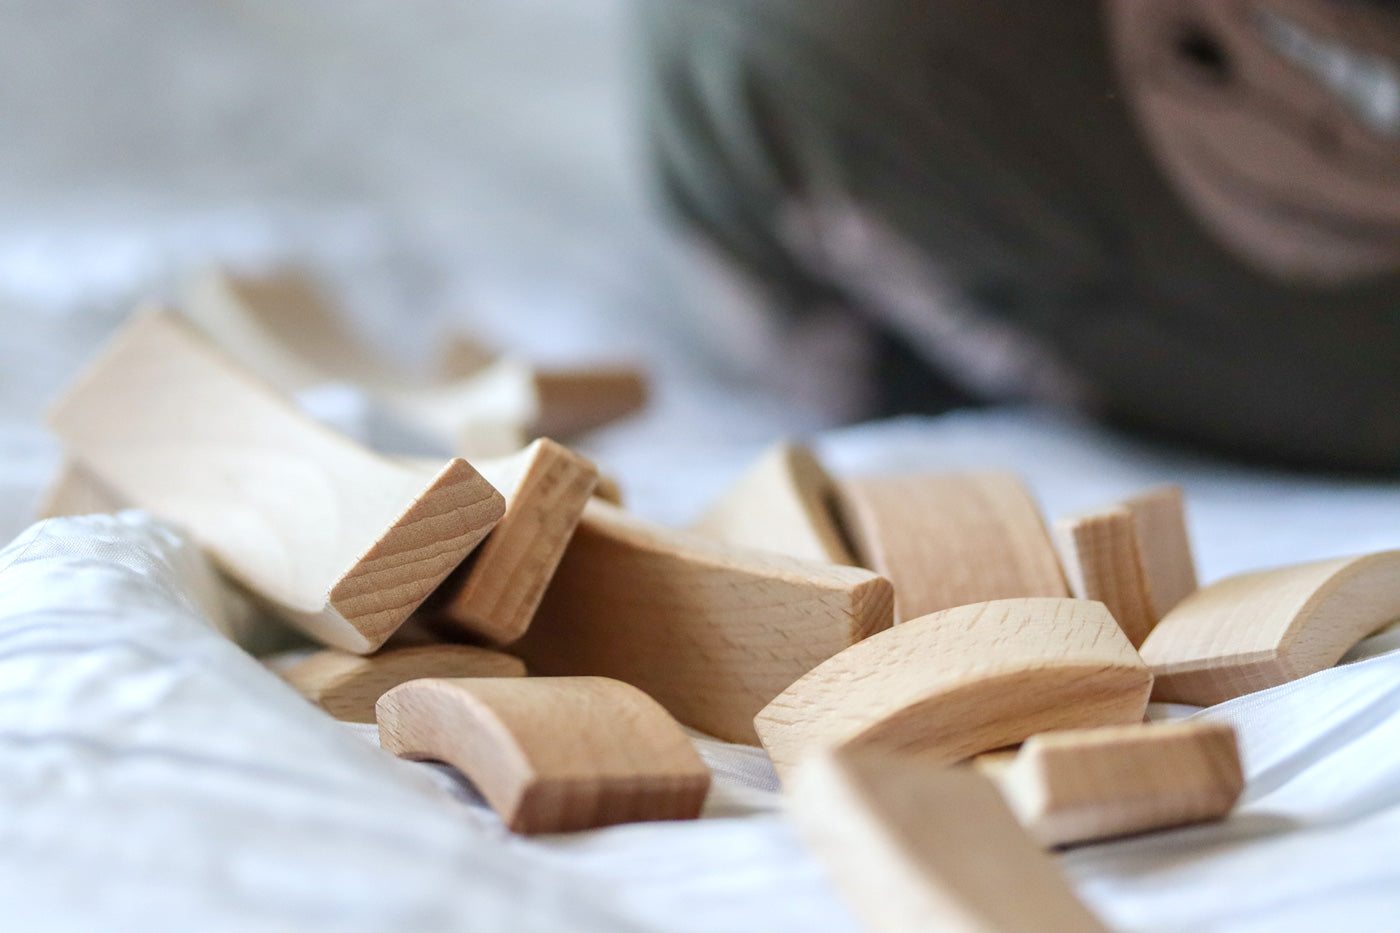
[753,598,1152,779]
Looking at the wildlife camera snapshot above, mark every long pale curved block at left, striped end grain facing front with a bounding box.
[49,311,505,653]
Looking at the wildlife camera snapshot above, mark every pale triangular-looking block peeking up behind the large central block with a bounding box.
[692,443,855,566]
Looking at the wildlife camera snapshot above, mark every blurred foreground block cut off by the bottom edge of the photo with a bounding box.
[790,749,1107,933]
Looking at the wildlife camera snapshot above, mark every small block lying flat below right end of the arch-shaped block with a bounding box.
[997,721,1245,846]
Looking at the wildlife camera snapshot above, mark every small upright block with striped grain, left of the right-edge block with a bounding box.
[1053,486,1196,646]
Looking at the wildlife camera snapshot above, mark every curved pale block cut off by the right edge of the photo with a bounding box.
[1141,551,1400,706]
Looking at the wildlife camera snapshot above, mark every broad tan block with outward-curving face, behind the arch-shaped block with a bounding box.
[837,474,1070,622]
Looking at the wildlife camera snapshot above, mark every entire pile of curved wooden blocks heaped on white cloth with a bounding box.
[48,275,1400,932]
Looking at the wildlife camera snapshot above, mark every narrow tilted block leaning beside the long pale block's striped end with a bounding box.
[426,438,598,644]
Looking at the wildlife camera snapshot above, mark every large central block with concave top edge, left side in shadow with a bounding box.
[512,499,892,744]
